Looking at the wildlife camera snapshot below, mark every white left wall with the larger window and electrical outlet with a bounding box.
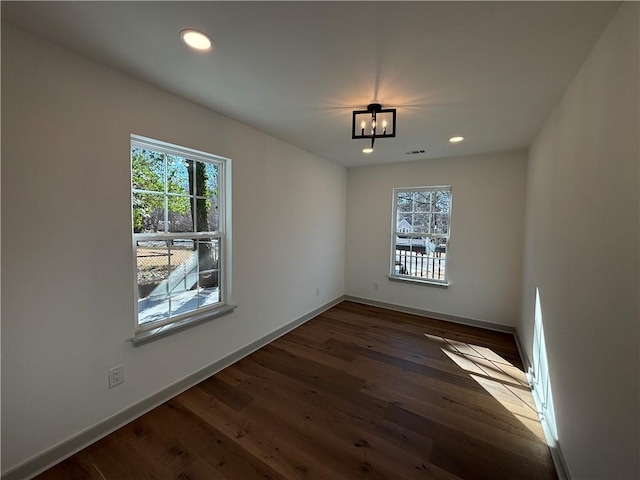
[2,24,346,472]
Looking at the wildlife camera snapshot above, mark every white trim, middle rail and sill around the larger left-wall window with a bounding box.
[129,134,237,346]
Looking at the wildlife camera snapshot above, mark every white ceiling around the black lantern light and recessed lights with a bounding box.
[2,1,619,166]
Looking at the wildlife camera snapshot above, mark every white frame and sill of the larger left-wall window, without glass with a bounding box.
[129,134,235,345]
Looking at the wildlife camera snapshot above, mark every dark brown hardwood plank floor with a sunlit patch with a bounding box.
[38,302,557,480]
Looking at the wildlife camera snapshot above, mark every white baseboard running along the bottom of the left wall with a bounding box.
[1,295,344,480]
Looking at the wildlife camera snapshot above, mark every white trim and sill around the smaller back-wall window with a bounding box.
[387,185,453,288]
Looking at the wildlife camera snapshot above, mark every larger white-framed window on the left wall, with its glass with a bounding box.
[131,135,230,343]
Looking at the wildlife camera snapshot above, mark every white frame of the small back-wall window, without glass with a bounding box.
[387,185,453,287]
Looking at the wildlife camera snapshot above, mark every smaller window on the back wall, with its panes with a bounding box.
[390,186,451,285]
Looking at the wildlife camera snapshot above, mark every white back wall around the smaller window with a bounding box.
[345,152,526,327]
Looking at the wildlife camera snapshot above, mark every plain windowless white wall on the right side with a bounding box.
[518,2,640,480]
